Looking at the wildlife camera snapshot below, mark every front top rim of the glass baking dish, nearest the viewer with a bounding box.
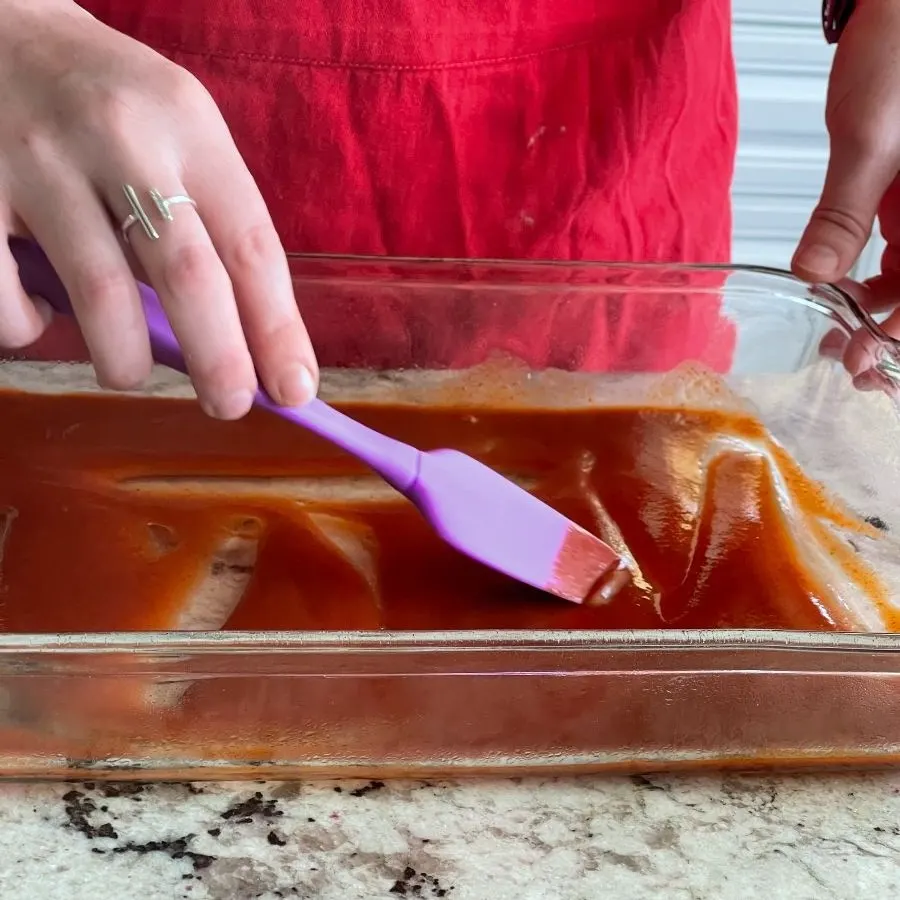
[0,629,900,657]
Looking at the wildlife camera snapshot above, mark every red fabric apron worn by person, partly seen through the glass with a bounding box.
[44,0,737,369]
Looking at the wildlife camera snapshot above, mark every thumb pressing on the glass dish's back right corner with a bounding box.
[791,136,896,282]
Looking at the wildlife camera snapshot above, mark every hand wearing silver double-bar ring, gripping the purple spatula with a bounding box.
[0,0,318,418]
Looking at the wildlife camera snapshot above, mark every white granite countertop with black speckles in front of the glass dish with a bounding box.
[0,773,900,900]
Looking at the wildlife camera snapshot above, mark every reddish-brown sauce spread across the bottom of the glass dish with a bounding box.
[0,393,886,632]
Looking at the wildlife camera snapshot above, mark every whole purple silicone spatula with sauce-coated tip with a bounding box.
[10,238,630,603]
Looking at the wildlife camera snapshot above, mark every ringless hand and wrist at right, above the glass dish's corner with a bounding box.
[792,0,900,282]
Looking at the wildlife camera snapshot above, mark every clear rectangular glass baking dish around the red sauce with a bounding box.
[0,257,900,779]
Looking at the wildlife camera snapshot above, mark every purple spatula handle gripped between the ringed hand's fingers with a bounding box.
[9,238,420,493]
